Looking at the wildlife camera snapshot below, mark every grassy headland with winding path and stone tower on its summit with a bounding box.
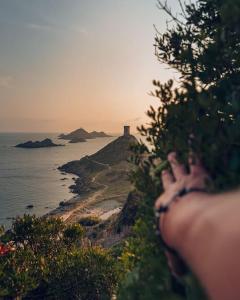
[50,126,137,223]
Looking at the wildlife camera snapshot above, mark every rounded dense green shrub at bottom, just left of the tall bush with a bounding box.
[45,247,117,300]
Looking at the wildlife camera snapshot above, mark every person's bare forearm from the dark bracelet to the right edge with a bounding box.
[163,192,240,300]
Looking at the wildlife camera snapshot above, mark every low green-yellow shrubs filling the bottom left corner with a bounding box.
[0,215,117,300]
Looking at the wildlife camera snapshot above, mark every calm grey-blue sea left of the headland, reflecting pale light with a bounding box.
[0,133,116,227]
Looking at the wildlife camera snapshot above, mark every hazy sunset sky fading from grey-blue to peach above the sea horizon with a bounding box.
[0,0,182,133]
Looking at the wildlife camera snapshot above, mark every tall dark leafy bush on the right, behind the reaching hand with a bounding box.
[118,0,240,300]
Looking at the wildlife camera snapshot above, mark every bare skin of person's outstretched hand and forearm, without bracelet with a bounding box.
[155,153,240,300]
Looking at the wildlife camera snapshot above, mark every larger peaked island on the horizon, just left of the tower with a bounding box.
[58,128,110,143]
